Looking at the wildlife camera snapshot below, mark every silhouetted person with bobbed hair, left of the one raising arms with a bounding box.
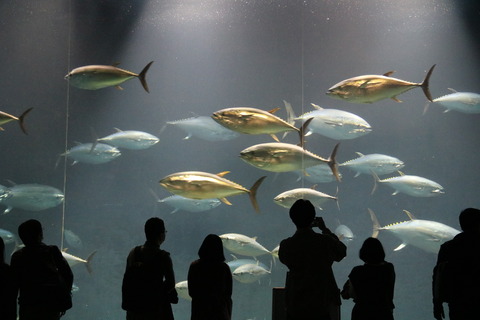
[188,234,232,320]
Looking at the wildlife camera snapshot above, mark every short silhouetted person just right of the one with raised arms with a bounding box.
[342,238,395,320]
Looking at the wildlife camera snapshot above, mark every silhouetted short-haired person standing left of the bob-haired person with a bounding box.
[122,218,178,320]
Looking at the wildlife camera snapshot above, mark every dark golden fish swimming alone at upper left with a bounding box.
[65,61,153,92]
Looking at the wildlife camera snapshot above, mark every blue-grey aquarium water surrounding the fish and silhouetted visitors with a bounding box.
[0,0,480,320]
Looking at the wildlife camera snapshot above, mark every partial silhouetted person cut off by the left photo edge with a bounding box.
[0,237,17,320]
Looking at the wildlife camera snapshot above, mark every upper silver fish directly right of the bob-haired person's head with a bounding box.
[220,233,271,257]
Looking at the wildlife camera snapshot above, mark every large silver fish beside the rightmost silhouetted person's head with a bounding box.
[368,209,460,253]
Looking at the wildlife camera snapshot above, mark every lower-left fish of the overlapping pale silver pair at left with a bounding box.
[61,143,122,165]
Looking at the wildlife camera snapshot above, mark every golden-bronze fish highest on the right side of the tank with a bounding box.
[327,65,435,103]
